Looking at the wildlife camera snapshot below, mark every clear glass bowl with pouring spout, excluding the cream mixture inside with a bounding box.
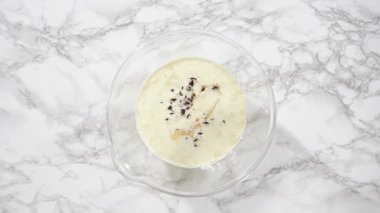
[107,30,275,196]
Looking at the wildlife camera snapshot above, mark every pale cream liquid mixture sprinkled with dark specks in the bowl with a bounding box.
[136,58,246,168]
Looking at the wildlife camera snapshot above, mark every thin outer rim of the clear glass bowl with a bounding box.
[106,29,276,197]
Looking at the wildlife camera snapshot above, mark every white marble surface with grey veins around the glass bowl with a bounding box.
[0,0,380,213]
